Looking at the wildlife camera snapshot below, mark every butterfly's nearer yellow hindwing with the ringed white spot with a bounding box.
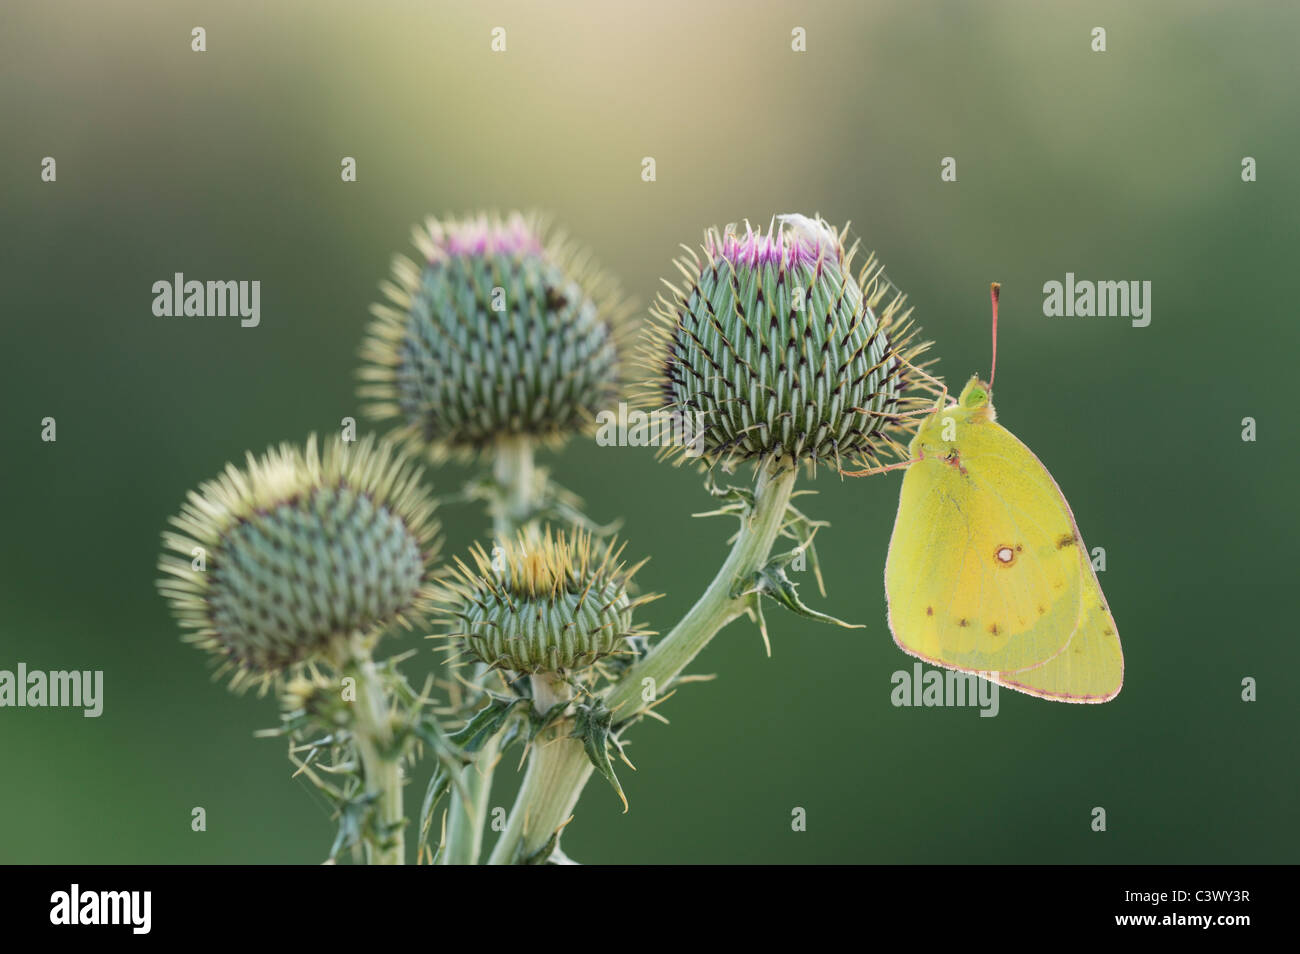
[885,417,1097,675]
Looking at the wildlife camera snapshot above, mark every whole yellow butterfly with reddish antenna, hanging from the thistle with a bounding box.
[863,285,1125,702]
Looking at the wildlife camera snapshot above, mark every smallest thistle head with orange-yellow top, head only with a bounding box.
[436,530,655,673]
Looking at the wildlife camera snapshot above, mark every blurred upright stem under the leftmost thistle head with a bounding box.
[352,637,406,864]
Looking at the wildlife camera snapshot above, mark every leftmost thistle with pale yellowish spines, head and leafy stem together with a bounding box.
[159,435,441,860]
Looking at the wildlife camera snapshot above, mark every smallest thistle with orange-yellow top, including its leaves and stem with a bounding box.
[434,530,655,862]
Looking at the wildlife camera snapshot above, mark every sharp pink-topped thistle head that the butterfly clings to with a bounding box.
[641,214,926,467]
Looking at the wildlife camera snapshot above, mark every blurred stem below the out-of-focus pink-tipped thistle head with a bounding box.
[439,438,536,864]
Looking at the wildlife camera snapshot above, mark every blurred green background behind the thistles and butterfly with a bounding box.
[0,0,1300,863]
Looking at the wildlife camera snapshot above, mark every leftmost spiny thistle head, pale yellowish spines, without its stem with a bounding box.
[159,435,437,686]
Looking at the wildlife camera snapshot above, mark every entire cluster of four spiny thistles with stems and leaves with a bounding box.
[161,213,933,864]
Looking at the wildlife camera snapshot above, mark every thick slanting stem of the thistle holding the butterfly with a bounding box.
[490,467,798,864]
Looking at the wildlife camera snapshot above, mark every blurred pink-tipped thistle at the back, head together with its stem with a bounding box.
[359,213,632,863]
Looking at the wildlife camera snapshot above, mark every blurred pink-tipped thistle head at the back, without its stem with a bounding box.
[359,213,629,459]
